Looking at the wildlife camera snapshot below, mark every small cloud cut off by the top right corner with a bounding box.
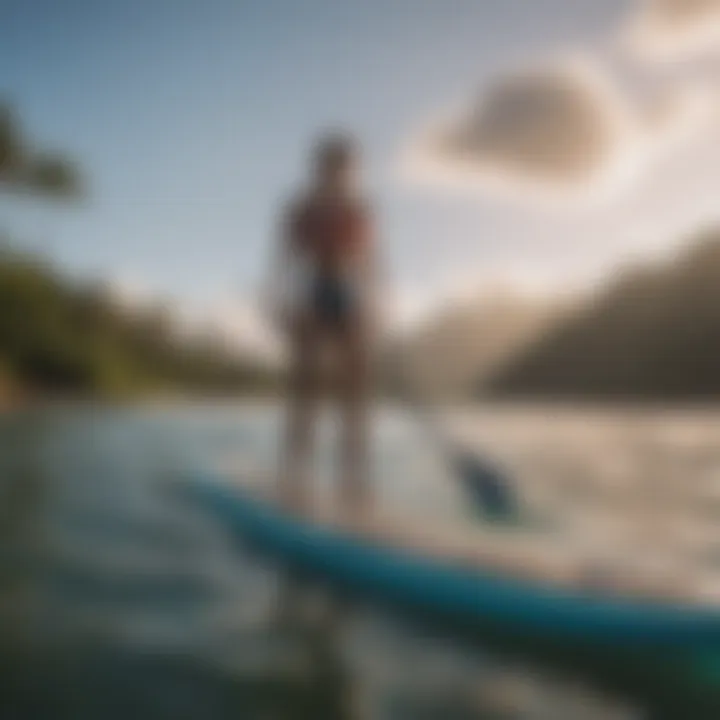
[622,0,720,60]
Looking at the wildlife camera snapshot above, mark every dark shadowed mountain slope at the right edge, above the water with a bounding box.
[478,229,720,400]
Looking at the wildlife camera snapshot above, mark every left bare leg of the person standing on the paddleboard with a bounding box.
[280,319,320,509]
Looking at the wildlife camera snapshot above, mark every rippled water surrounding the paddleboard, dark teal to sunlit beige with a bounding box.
[0,405,720,720]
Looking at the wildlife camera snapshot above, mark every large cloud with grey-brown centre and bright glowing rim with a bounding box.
[403,58,635,198]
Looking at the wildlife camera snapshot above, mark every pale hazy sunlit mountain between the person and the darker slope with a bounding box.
[394,292,559,397]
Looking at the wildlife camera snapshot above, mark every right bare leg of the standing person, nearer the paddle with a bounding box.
[336,323,372,514]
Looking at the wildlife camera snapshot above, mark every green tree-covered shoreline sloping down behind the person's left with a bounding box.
[0,250,273,397]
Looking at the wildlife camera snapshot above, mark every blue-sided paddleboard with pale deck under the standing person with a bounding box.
[181,477,720,687]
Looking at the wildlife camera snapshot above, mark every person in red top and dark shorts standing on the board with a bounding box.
[274,133,377,514]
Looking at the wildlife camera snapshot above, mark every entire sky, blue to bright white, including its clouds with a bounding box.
[0,0,720,344]
